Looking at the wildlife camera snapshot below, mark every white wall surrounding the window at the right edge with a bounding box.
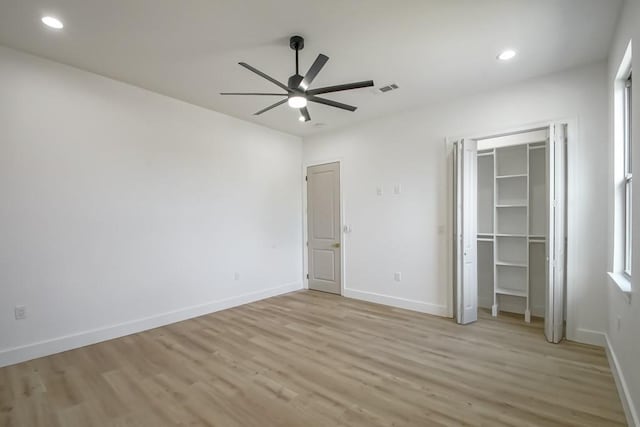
[605,0,640,426]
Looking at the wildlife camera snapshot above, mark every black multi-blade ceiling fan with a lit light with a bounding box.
[220,36,373,122]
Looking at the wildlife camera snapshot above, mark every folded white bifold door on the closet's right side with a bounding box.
[544,124,567,343]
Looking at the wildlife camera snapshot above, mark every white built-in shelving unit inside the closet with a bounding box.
[477,141,546,322]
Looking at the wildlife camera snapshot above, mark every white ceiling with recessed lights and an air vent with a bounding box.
[0,0,621,135]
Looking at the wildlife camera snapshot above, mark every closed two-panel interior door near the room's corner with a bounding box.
[307,162,342,294]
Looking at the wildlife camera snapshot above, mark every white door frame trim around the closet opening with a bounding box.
[444,117,582,341]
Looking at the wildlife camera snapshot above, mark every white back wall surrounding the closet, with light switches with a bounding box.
[304,63,608,344]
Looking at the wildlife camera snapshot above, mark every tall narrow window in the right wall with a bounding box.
[623,73,633,276]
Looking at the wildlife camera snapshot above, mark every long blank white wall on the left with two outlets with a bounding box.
[0,47,302,366]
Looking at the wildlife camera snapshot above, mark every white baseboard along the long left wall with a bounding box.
[0,282,302,367]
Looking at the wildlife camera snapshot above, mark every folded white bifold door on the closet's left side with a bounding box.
[454,139,478,324]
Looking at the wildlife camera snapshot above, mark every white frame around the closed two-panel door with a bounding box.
[301,157,347,296]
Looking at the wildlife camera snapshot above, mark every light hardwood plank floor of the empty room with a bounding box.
[0,291,625,427]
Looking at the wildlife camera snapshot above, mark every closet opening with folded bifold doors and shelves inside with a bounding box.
[453,123,567,342]
